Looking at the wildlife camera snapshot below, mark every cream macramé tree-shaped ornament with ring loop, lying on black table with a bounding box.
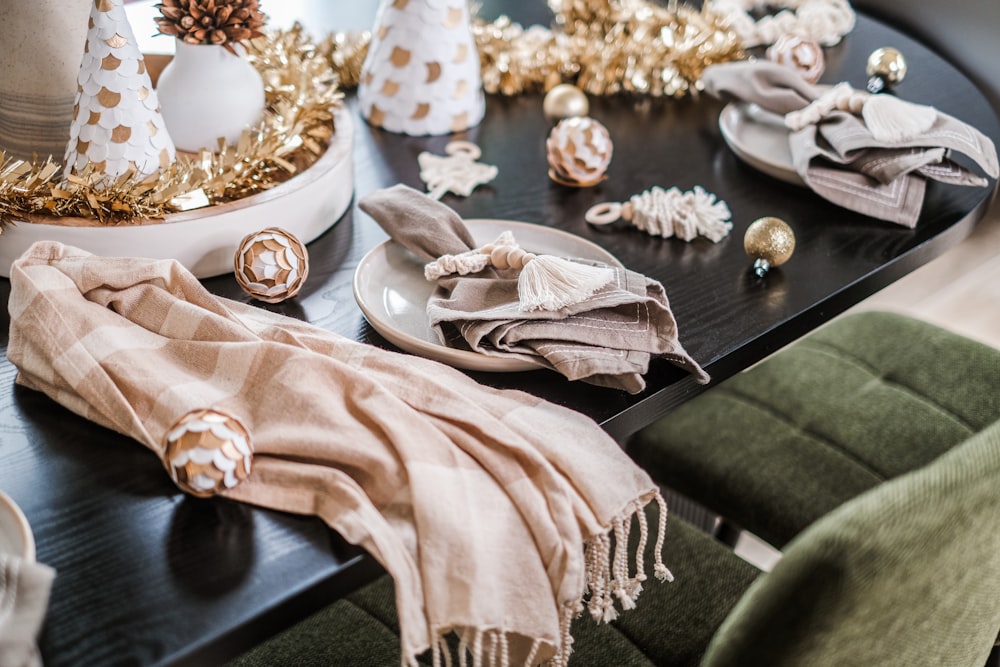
[584,185,733,243]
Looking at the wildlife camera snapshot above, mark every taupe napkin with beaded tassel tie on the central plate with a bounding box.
[358,185,710,394]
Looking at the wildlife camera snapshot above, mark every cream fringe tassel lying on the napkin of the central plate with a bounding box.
[517,255,615,310]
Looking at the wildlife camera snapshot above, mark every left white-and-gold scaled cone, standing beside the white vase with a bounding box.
[65,0,174,179]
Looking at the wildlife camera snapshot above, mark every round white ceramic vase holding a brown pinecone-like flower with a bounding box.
[156,40,264,153]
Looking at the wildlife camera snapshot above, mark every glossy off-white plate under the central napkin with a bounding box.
[354,219,621,373]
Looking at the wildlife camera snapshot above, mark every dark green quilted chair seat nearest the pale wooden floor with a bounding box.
[627,312,1000,548]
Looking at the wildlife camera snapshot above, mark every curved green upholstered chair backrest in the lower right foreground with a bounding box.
[702,422,1000,667]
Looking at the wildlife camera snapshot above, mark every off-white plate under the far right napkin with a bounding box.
[719,102,805,185]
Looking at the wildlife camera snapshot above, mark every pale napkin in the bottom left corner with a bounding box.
[0,553,55,667]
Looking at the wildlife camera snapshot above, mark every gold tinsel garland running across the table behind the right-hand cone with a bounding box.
[316,0,745,97]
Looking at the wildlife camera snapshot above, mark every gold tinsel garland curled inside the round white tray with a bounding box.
[0,25,343,226]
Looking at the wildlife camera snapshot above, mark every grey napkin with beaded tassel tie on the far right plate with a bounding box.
[702,60,1000,227]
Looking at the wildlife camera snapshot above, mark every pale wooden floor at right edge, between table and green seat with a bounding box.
[853,202,1000,348]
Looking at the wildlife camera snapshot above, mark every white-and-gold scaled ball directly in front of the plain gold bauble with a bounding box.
[545,117,614,188]
